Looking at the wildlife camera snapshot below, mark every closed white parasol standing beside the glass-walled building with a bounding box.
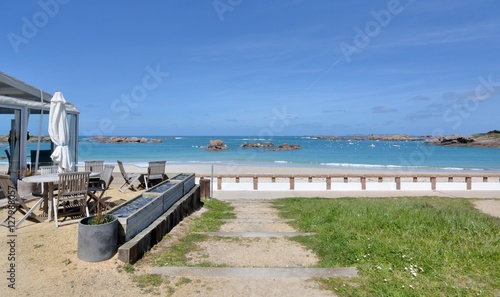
[49,92,73,172]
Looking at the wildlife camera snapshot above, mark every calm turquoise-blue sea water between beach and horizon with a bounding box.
[14,136,500,171]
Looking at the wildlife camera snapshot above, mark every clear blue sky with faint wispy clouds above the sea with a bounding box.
[0,0,500,135]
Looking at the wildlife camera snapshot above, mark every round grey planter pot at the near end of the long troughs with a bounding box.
[78,214,118,262]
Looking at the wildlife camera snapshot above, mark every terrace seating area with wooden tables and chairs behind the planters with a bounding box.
[0,160,172,228]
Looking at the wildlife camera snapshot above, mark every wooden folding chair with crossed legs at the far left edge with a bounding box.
[0,174,45,228]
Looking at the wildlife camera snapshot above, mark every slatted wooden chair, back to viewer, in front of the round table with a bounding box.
[53,171,90,227]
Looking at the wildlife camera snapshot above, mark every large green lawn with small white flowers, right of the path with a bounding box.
[276,197,500,296]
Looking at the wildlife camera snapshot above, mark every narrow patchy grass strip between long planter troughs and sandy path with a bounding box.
[147,199,235,266]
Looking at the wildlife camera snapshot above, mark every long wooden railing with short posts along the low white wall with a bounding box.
[197,173,500,190]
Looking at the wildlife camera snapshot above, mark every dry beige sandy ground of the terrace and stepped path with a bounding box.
[0,172,500,296]
